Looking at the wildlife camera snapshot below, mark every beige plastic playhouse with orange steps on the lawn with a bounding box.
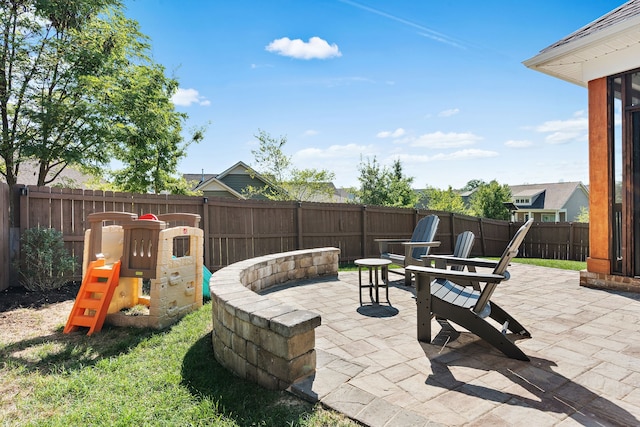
[64,212,206,335]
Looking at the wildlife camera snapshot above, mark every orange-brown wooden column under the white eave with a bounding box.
[587,77,613,274]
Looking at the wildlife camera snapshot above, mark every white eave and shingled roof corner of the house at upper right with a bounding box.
[524,0,640,86]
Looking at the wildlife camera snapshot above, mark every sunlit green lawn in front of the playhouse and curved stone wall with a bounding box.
[0,303,356,426]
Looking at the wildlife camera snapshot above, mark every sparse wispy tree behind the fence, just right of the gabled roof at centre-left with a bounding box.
[245,129,335,201]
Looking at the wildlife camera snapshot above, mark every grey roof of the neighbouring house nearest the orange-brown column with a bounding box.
[509,182,589,210]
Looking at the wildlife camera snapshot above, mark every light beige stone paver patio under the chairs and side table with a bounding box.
[262,264,640,427]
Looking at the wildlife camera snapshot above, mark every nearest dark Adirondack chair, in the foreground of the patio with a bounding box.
[406,219,533,361]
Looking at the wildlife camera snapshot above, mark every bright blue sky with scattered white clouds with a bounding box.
[125,0,624,189]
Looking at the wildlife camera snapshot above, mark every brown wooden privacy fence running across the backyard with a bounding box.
[0,186,589,289]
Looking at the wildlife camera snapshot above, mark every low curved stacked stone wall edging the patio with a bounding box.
[209,248,340,390]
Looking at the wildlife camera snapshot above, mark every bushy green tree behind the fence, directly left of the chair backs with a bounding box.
[355,157,419,207]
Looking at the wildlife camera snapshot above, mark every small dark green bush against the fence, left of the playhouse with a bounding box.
[17,227,76,291]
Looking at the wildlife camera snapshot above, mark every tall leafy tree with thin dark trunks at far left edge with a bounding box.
[0,0,122,189]
